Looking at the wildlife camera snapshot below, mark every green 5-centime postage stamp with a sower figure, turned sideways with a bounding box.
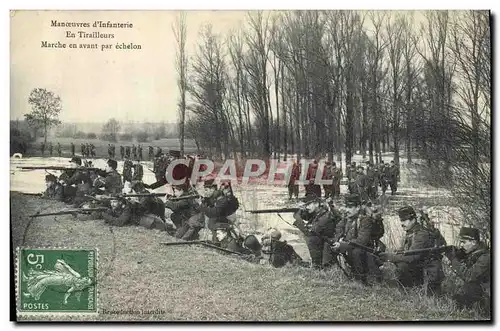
[16,248,98,315]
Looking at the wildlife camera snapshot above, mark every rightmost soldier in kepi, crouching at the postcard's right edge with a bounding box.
[446,227,491,310]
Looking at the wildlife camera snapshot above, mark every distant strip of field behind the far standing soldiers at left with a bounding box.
[23,138,196,159]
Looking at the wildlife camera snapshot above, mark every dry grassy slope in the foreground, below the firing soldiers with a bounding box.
[11,193,485,322]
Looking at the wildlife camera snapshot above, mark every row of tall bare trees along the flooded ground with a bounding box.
[175,11,491,236]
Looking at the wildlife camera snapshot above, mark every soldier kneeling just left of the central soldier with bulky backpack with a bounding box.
[165,184,199,232]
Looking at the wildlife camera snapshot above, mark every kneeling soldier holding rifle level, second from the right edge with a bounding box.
[379,206,444,294]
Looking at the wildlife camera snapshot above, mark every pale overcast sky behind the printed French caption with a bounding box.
[10,11,252,123]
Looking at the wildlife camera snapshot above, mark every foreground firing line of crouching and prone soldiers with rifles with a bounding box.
[38,152,490,307]
